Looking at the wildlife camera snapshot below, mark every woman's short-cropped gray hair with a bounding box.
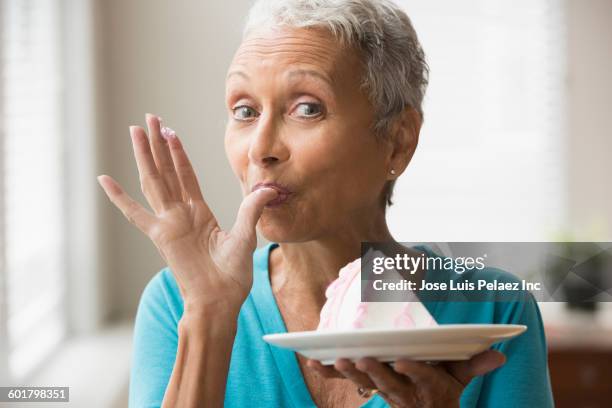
[243,0,429,206]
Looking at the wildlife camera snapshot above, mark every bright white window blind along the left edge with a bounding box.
[0,0,66,380]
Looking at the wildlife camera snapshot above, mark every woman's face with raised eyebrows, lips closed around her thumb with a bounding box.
[225,28,389,242]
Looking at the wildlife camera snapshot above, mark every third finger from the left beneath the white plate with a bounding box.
[355,357,413,401]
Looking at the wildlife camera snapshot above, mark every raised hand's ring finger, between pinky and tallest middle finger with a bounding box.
[130,126,169,213]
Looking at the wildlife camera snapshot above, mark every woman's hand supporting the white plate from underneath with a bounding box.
[307,350,506,408]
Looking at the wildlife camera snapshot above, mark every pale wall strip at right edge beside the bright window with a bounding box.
[567,0,612,240]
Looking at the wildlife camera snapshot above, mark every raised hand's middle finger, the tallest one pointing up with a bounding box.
[145,113,183,201]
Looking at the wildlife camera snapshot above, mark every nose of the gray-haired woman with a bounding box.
[249,111,289,167]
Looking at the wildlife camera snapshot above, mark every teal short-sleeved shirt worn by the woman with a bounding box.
[129,243,553,408]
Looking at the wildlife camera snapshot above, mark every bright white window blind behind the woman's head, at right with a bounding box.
[388,0,566,242]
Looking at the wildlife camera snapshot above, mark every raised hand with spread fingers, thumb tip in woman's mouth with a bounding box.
[98,114,277,311]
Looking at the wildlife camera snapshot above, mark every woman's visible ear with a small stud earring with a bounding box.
[389,106,422,177]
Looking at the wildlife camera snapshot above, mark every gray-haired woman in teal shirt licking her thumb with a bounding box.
[99,0,551,407]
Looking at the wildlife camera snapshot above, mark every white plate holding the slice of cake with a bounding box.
[263,324,527,364]
